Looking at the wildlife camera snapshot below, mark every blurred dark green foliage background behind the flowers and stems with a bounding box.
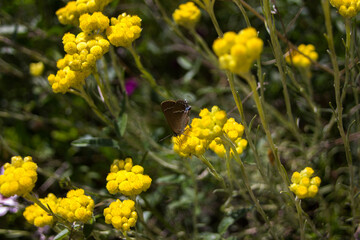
[0,0,359,239]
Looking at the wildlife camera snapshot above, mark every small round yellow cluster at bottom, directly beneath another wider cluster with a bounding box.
[104,199,138,232]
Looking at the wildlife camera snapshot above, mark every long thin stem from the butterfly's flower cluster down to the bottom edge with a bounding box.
[222,135,279,239]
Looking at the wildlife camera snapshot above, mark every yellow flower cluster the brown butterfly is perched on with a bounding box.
[172,106,247,157]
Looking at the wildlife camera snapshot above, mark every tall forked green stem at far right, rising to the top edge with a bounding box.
[321,0,356,231]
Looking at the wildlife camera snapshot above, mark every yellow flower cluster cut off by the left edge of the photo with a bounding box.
[0,156,37,197]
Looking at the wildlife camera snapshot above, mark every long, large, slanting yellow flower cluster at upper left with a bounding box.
[48,32,110,93]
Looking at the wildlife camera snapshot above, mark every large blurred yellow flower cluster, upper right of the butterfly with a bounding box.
[213,27,264,75]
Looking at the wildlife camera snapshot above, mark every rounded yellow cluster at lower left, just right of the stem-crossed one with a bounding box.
[56,189,94,223]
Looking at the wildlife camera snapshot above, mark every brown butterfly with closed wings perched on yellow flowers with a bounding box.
[161,100,191,136]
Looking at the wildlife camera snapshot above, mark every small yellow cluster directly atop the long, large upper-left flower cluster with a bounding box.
[79,12,110,33]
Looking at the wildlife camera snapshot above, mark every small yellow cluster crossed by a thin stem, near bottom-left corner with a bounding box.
[23,193,59,227]
